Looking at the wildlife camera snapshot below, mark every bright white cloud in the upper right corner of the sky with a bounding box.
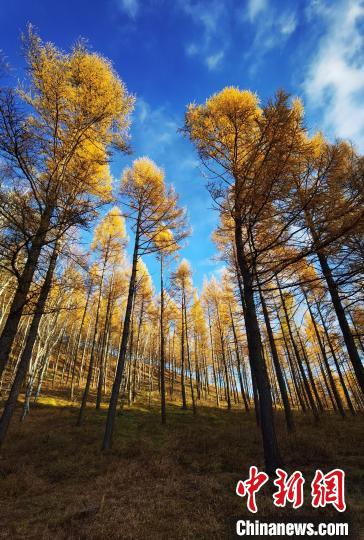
[303,0,364,151]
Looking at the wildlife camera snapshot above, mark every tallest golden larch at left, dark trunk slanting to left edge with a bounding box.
[0,27,133,375]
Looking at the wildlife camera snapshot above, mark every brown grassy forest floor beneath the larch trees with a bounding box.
[0,394,364,540]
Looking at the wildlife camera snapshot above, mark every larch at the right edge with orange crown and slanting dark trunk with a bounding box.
[295,137,364,393]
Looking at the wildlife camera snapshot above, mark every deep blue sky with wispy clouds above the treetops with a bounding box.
[0,0,364,287]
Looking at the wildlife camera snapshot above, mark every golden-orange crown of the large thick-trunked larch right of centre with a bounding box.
[185,87,307,220]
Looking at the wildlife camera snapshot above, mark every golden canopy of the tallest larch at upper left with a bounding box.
[19,26,134,203]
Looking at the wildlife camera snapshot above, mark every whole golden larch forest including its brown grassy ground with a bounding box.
[0,26,364,538]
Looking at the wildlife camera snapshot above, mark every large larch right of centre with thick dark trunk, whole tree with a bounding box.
[184,87,303,472]
